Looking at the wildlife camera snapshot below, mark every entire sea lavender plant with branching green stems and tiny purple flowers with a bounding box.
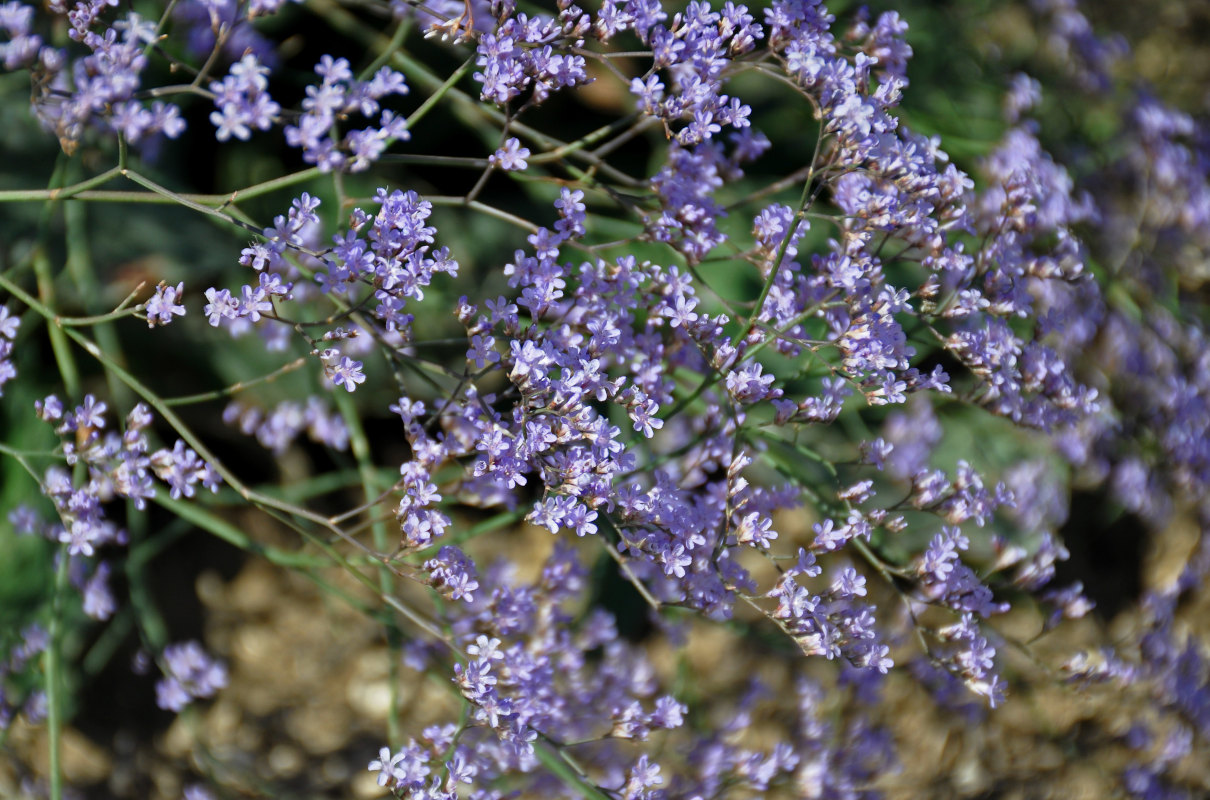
[0,0,1210,800]
